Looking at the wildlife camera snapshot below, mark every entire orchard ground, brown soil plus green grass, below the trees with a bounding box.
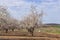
[0,26,60,40]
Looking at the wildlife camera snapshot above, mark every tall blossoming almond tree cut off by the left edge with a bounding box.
[0,6,10,33]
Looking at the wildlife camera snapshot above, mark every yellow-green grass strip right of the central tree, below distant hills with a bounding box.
[34,26,60,34]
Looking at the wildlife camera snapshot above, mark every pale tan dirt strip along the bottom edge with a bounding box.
[0,36,60,40]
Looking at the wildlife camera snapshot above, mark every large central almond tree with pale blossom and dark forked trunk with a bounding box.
[23,6,43,36]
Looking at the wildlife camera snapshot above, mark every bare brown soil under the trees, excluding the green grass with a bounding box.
[0,29,60,40]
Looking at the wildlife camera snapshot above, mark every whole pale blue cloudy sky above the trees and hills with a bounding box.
[0,0,60,23]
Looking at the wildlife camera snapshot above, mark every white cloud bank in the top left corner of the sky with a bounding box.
[0,0,24,6]
